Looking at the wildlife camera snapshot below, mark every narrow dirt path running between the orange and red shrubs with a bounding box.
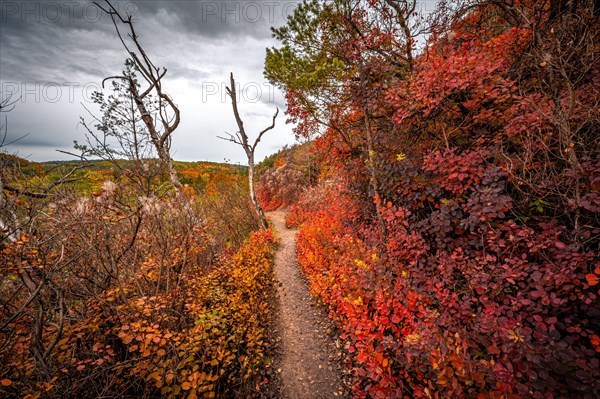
[267,211,344,399]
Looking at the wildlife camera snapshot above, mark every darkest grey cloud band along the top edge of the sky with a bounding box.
[0,0,298,38]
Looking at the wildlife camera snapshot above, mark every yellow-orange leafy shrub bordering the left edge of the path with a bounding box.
[63,228,273,398]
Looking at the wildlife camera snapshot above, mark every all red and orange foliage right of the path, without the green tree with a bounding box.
[288,2,600,399]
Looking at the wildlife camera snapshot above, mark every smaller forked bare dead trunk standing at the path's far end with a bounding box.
[218,73,279,229]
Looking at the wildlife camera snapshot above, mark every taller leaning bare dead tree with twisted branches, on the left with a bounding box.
[94,0,189,209]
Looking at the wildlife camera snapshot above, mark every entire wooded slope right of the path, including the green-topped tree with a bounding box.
[259,0,600,398]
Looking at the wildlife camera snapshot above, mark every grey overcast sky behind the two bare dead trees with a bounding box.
[0,0,297,163]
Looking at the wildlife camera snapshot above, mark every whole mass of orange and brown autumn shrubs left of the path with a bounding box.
[0,182,273,398]
